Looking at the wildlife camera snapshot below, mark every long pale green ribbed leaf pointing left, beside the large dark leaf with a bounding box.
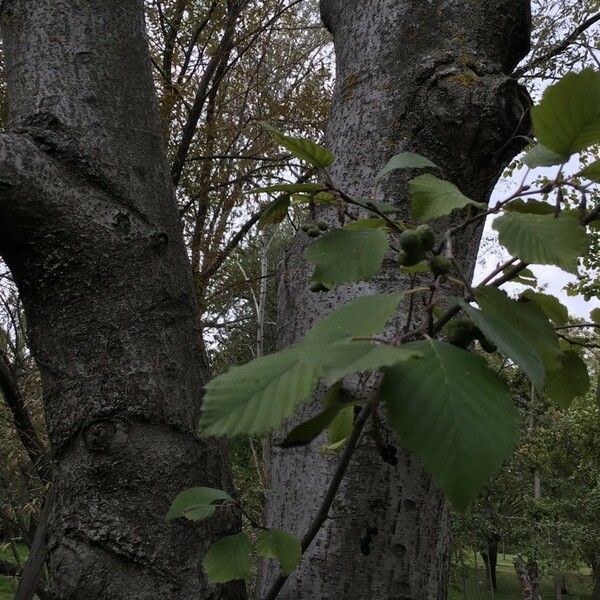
[199,294,418,436]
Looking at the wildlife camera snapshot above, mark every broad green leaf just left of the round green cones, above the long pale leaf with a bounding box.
[306,229,389,288]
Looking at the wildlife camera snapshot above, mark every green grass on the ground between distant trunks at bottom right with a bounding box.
[448,554,592,600]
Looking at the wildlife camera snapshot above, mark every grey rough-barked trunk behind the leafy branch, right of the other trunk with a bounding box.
[261,0,530,600]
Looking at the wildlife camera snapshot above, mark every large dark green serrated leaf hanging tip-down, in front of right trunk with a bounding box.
[381,340,519,510]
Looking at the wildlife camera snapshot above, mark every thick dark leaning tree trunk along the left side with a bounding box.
[0,0,244,600]
